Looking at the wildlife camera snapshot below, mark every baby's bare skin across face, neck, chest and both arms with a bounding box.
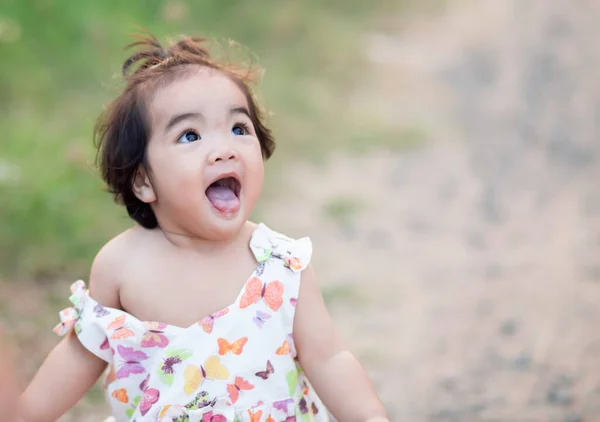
[20,68,388,422]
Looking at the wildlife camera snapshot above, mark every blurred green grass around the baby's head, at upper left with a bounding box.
[0,0,419,279]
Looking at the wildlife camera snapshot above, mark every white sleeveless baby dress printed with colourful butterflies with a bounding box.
[54,224,329,422]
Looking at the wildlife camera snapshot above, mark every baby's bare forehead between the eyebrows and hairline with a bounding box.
[148,67,248,125]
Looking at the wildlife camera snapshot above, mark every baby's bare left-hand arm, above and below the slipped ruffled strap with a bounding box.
[19,241,122,422]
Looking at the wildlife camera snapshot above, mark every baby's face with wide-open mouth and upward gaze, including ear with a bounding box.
[141,68,264,240]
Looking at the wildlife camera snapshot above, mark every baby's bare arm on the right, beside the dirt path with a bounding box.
[294,266,388,422]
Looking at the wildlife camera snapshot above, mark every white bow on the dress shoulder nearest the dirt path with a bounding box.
[250,223,312,273]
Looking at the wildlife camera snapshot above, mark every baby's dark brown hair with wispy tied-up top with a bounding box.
[94,35,275,229]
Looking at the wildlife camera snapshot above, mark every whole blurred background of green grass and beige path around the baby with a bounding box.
[0,0,600,422]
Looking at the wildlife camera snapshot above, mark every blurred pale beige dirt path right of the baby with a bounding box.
[265,0,600,422]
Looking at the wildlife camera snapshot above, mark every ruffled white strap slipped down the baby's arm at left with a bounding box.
[53,280,113,362]
